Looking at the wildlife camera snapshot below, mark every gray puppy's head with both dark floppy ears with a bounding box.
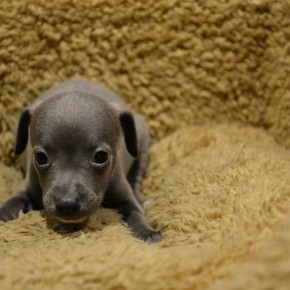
[15,93,138,222]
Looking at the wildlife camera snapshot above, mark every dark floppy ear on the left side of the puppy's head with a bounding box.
[15,109,31,155]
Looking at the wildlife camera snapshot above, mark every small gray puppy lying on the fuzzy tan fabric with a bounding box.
[0,80,161,243]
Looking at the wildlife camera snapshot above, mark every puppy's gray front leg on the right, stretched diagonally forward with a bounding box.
[103,178,162,243]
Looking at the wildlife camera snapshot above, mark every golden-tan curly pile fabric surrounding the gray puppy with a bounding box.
[0,0,290,290]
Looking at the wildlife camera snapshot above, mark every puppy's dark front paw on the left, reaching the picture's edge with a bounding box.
[0,190,40,222]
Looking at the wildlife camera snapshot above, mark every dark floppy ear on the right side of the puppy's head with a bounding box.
[120,112,139,157]
